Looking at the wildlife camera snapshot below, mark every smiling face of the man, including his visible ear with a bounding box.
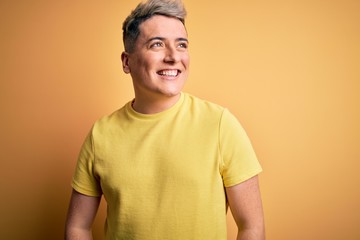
[122,15,189,100]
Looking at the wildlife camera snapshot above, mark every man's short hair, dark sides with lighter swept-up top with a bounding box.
[122,0,186,53]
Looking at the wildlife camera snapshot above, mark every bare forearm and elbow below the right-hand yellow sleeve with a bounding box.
[226,176,265,240]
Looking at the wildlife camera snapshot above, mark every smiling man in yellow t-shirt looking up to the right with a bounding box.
[66,0,265,240]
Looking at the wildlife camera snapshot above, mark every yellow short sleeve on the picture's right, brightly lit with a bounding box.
[219,109,262,187]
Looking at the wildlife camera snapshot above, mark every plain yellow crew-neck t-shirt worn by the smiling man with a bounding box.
[72,93,261,240]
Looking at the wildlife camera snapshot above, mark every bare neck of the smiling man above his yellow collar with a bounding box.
[132,93,181,114]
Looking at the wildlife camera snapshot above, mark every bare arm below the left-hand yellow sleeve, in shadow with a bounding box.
[65,190,101,240]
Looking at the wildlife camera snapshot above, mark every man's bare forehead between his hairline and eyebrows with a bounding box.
[139,15,187,39]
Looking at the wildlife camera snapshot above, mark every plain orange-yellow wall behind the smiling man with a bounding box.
[0,0,360,240]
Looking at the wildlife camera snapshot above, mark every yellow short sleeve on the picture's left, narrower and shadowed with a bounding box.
[71,131,102,197]
